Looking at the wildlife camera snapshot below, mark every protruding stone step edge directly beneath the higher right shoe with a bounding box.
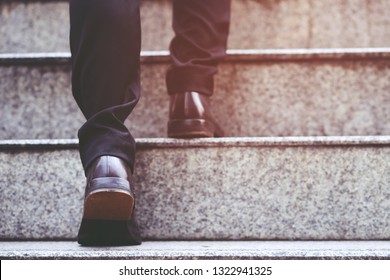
[0,135,390,151]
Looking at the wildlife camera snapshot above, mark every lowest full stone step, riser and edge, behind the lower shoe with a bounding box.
[0,136,390,240]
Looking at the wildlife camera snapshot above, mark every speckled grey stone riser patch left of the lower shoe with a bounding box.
[0,150,84,239]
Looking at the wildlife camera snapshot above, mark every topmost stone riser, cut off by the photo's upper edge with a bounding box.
[0,0,390,52]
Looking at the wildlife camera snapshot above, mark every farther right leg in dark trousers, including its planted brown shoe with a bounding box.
[166,0,231,137]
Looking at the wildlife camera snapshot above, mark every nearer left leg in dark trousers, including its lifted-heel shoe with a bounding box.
[70,0,141,244]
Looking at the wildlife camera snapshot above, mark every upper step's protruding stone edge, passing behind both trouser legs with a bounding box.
[0,48,390,66]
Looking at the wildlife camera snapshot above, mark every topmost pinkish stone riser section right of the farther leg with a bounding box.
[229,0,390,49]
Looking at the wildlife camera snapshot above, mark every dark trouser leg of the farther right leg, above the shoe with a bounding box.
[166,0,231,95]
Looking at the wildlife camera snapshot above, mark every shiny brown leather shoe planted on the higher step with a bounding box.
[168,91,223,138]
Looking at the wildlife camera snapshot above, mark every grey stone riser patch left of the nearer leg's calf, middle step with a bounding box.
[0,66,84,139]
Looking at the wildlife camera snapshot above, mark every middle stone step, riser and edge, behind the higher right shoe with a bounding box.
[0,48,390,139]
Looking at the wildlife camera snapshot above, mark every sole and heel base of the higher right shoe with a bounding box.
[168,119,223,138]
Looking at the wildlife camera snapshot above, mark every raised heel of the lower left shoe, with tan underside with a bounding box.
[83,177,134,221]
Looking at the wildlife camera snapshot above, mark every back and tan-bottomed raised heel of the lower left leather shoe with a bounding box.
[83,156,134,221]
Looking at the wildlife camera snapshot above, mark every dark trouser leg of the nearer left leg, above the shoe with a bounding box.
[70,0,141,173]
